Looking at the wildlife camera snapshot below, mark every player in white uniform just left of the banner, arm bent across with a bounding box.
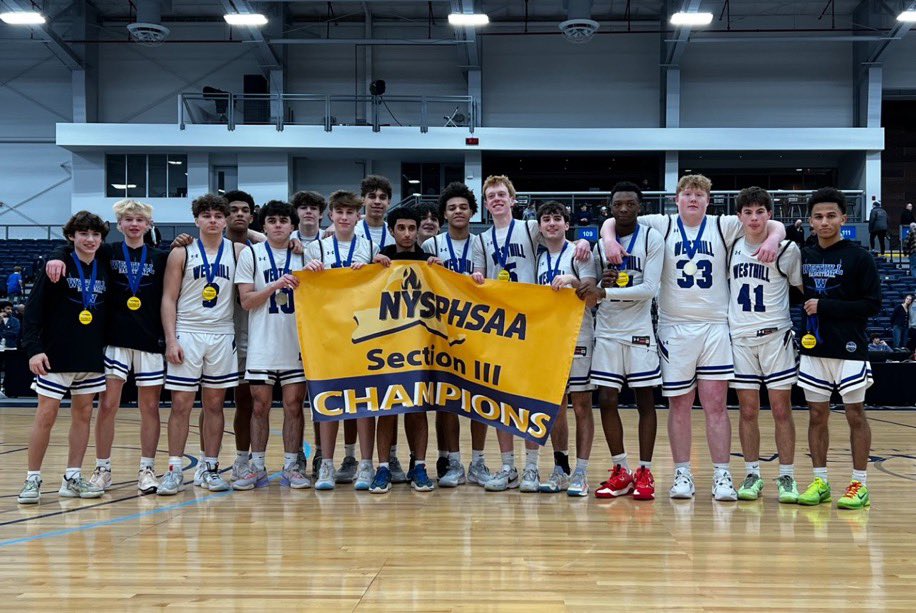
[232,200,312,490]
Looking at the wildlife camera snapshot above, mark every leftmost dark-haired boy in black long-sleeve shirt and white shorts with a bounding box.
[17,211,108,504]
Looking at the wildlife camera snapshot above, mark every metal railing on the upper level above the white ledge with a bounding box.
[178,92,479,132]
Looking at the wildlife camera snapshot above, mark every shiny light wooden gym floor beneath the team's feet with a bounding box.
[0,408,916,612]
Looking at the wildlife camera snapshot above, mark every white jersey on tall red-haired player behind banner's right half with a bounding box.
[471,219,541,283]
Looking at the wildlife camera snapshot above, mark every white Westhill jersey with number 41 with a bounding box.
[728,236,802,340]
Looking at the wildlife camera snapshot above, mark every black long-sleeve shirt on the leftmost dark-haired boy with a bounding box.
[22,249,109,372]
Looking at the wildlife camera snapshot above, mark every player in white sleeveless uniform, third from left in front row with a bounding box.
[158,194,242,496]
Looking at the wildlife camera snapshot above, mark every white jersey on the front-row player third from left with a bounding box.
[176,238,235,334]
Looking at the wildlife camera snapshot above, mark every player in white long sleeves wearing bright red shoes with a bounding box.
[579,182,665,500]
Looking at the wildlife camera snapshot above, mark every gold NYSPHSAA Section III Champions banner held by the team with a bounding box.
[295,262,583,444]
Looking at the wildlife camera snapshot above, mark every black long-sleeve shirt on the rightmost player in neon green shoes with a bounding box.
[801,240,881,360]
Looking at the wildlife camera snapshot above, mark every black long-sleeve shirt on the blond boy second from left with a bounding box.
[51,242,168,353]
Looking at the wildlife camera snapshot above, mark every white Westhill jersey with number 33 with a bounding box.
[639,214,742,325]
